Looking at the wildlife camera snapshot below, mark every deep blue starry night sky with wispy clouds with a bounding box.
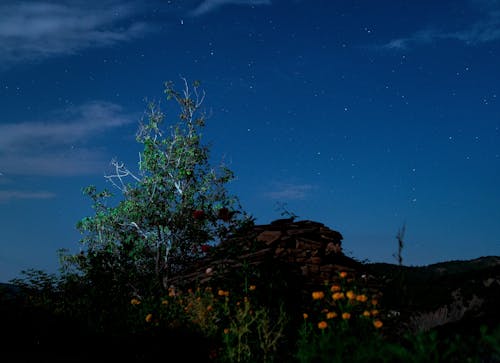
[0,0,500,281]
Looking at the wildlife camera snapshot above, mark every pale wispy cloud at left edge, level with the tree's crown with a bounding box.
[0,102,134,176]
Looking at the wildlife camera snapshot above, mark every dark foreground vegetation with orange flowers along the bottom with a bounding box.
[0,257,500,362]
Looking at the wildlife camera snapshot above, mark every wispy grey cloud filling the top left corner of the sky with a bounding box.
[0,0,148,67]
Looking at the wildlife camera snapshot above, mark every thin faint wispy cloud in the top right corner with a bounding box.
[383,0,500,50]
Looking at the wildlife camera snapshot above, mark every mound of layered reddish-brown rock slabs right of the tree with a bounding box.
[167,218,378,298]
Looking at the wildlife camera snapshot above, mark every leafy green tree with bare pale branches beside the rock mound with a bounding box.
[62,78,254,295]
